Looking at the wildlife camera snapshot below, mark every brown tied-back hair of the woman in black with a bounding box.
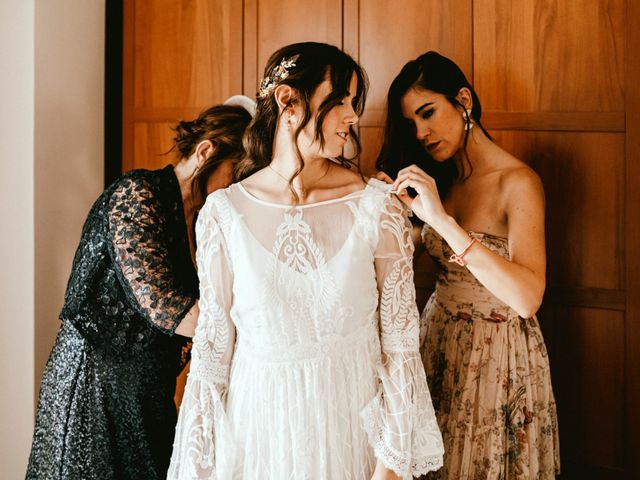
[173,105,251,200]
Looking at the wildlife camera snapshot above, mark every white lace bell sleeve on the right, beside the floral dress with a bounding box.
[362,197,444,478]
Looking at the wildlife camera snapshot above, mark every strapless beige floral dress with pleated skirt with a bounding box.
[421,225,560,480]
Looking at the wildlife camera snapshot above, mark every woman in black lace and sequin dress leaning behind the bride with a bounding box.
[26,101,251,480]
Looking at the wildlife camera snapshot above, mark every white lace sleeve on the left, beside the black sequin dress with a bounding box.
[167,197,235,480]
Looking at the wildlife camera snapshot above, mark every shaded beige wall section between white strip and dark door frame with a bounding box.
[35,0,105,390]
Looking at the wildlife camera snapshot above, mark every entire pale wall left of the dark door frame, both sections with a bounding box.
[0,0,105,479]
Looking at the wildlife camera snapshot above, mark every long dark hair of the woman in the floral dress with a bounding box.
[376,51,491,198]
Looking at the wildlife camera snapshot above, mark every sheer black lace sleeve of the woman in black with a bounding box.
[108,177,195,334]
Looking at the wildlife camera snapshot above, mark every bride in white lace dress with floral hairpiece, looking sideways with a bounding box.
[169,43,443,480]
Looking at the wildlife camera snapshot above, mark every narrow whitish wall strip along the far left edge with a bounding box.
[0,0,35,479]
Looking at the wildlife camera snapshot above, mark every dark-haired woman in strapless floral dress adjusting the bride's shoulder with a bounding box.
[378,52,559,480]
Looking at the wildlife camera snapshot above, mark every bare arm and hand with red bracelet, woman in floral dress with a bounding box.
[394,165,546,318]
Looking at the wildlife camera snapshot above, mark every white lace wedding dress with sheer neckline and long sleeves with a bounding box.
[169,180,443,480]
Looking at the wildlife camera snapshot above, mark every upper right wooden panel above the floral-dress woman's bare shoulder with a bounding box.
[473,0,625,112]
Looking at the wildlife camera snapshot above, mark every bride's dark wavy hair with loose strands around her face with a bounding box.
[236,42,369,191]
